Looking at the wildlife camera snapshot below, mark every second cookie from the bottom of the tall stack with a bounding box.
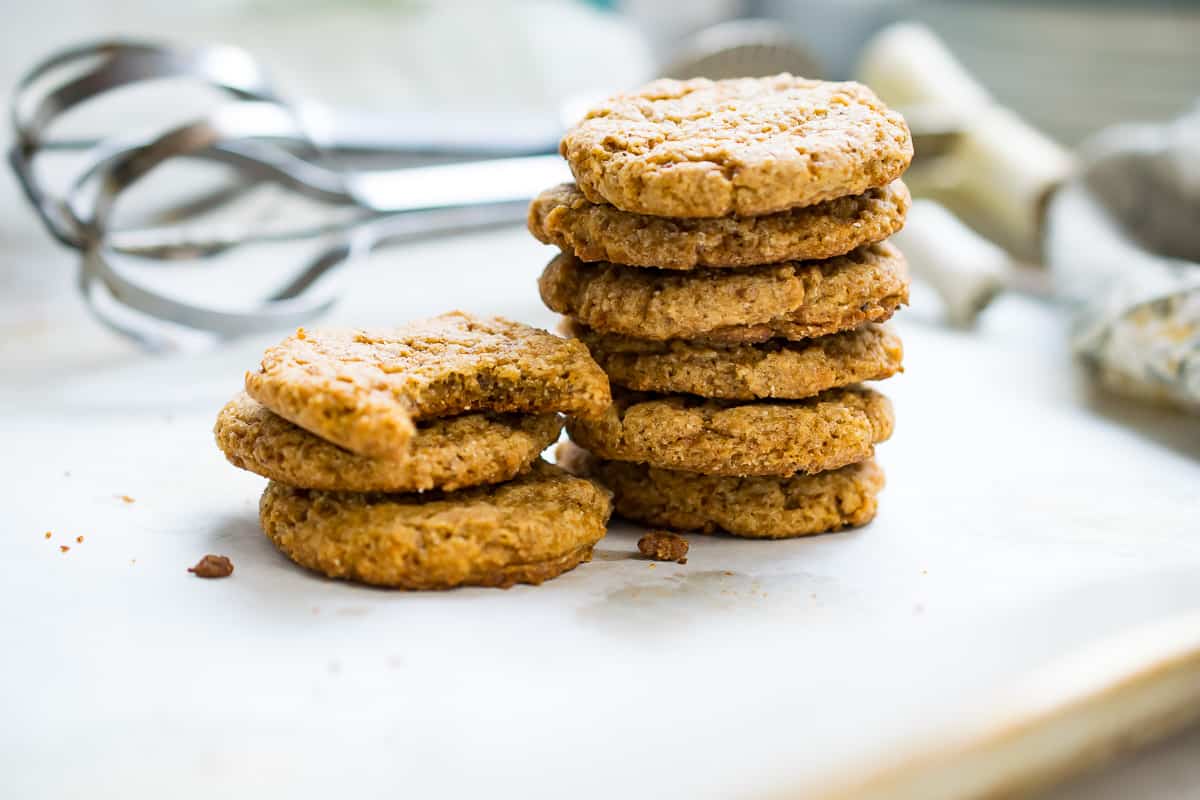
[566,387,893,476]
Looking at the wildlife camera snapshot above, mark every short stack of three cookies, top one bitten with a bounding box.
[215,312,611,589]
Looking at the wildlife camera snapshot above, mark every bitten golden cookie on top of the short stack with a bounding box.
[246,312,610,459]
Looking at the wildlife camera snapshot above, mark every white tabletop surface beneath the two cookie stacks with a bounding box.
[0,221,1200,798]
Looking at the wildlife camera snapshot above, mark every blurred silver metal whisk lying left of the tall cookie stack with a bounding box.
[10,42,566,347]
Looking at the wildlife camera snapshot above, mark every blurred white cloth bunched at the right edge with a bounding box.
[1045,107,1200,410]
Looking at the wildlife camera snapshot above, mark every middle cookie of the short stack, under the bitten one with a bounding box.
[214,395,563,492]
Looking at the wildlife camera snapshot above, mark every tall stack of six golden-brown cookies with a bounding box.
[529,74,912,537]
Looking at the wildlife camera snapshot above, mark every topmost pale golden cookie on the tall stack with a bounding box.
[559,74,912,217]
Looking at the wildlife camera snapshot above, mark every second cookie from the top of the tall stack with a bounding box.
[528,181,912,270]
